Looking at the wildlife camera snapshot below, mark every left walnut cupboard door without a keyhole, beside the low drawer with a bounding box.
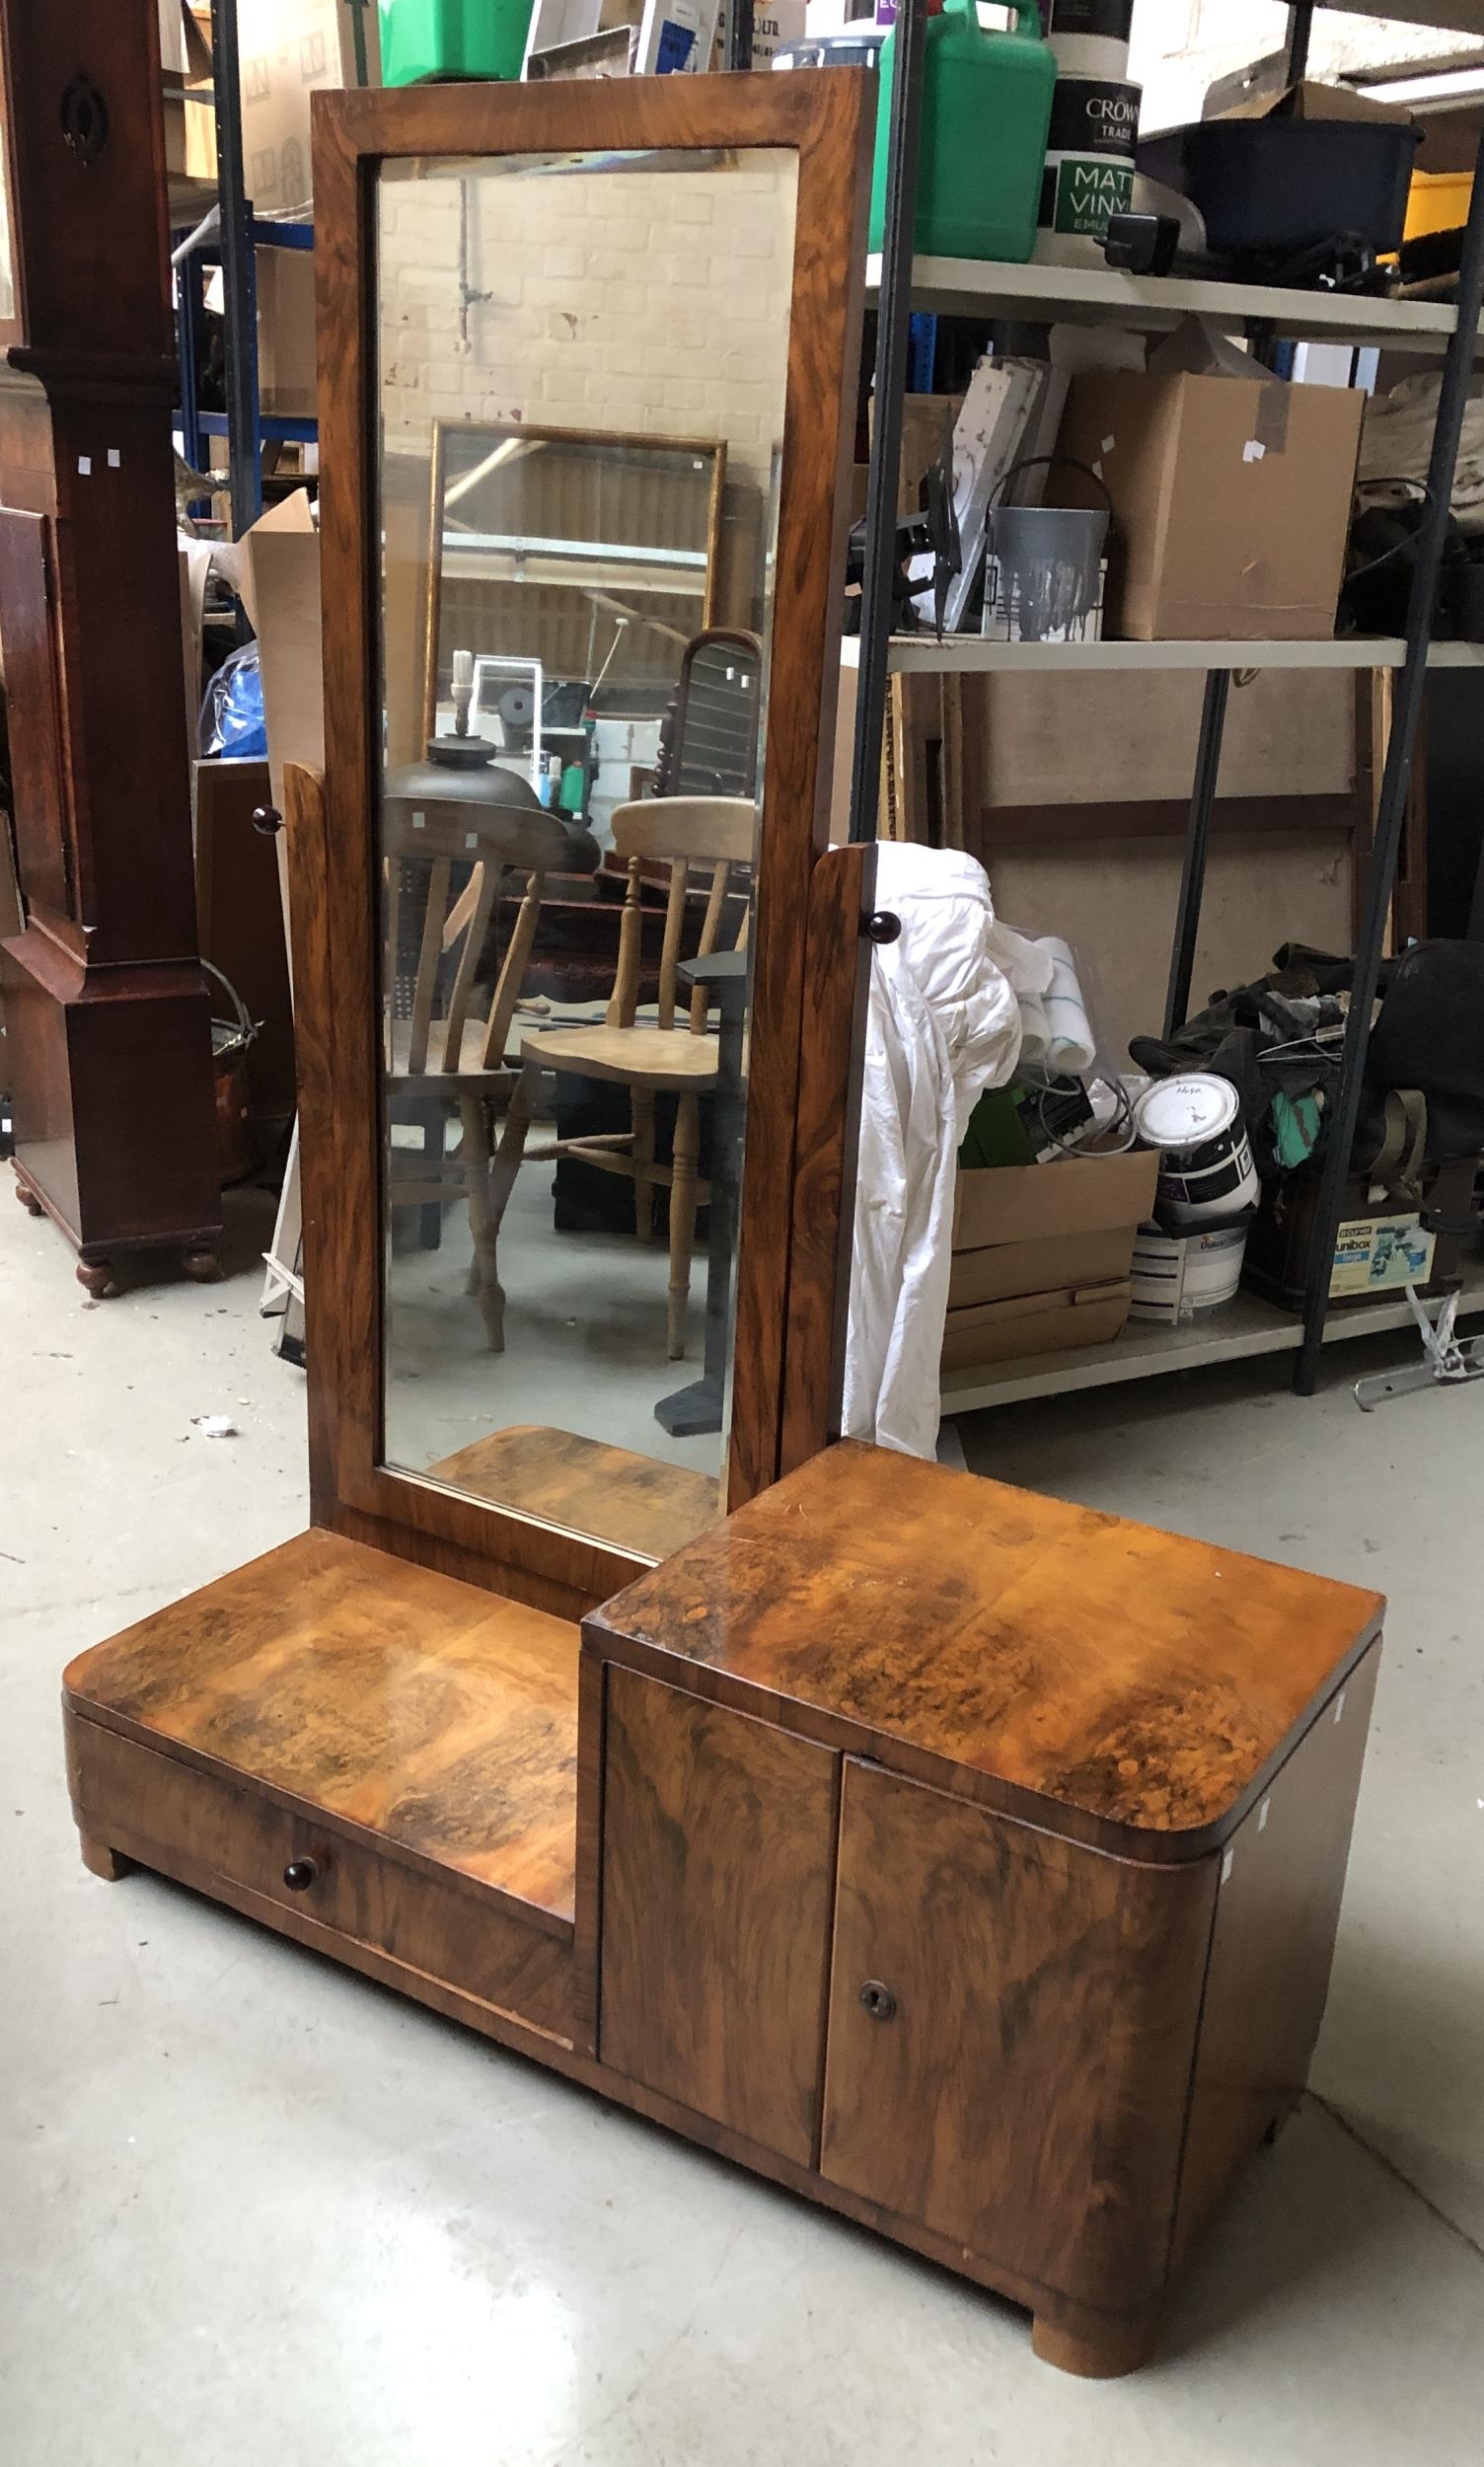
[599,1666,836,2166]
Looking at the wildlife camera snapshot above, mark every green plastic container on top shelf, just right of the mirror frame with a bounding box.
[870,0,1058,266]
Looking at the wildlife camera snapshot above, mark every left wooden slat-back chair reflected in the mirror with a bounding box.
[382,799,569,1352]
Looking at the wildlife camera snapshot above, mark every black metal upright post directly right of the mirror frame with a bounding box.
[851,0,927,839]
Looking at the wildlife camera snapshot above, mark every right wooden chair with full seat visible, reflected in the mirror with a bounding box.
[490,797,757,1362]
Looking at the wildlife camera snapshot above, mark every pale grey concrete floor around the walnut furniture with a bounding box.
[0,1202,1484,2467]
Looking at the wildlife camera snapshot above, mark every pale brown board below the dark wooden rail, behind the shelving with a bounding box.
[986,832,1351,1071]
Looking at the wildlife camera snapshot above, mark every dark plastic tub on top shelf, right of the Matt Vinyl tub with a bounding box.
[1139,118,1423,257]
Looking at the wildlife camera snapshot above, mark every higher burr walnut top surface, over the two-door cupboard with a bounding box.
[584,1441,1385,1858]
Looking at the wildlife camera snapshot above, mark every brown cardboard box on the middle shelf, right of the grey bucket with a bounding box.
[1060,370,1364,641]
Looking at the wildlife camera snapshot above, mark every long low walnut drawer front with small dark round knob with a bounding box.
[66,1715,572,2038]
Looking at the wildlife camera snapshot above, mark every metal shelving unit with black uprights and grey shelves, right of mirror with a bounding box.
[846,0,1484,1411]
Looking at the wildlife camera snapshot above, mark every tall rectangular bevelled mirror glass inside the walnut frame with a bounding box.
[377,148,796,1557]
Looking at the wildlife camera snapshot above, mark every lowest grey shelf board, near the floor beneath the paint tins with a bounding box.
[941,1263,1484,1414]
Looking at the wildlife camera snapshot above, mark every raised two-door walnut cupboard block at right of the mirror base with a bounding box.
[577,1446,1380,2373]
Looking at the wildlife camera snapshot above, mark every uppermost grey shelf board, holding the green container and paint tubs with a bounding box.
[865,255,1457,353]
